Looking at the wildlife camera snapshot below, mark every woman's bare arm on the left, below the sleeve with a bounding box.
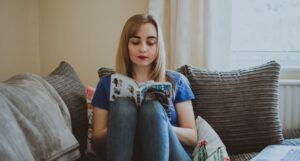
[92,107,108,145]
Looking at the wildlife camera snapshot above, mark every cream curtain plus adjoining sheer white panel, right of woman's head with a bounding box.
[149,0,231,69]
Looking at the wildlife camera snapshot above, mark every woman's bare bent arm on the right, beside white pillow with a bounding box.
[173,101,197,146]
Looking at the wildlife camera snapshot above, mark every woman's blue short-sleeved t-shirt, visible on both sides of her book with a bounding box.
[92,71,195,126]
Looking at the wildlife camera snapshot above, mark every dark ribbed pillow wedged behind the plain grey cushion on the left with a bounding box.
[46,61,88,154]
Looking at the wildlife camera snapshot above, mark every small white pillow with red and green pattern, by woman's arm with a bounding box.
[192,116,230,161]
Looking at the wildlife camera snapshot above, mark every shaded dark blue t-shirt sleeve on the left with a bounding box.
[92,76,110,110]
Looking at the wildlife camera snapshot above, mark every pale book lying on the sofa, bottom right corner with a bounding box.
[250,145,300,161]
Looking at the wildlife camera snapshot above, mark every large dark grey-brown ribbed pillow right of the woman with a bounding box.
[177,61,283,155]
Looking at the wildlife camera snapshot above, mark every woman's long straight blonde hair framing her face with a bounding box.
[116,14,166,81]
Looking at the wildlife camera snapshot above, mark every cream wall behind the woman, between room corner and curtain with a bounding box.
[39,0,148,86]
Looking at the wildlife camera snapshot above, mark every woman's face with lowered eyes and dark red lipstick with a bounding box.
[128,23,157,68]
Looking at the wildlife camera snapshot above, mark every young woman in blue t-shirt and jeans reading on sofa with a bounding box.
[92,14,197,161]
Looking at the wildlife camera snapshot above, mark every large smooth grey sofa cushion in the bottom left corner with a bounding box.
[0,73,80,161]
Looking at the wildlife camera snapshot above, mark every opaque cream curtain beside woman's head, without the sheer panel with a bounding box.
[149,0,206,69]
